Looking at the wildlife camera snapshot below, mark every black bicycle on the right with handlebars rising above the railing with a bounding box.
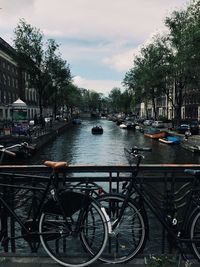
[94,147,200,263]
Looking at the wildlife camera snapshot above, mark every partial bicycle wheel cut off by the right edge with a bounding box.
[189,210,200,261]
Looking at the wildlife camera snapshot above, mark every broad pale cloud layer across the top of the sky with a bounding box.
[0,0,185,41]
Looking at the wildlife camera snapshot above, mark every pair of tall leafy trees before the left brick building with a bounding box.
[14,19,72,116]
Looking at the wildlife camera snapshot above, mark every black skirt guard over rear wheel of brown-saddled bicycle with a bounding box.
[42,191,90,217]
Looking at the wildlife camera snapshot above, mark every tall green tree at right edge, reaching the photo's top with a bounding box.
[165,0,200,124]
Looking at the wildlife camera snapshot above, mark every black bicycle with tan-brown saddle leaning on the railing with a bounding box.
[0,158,111,267]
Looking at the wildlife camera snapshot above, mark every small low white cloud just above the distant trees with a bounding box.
[73,76,122,95]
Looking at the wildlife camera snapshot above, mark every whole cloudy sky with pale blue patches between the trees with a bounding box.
[0,0,188,95]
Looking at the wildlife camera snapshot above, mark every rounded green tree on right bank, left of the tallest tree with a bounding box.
[123,36,169,119]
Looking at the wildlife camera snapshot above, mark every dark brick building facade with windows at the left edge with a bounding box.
[0,38,39,122]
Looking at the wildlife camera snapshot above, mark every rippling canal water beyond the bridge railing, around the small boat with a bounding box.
[27,119,200,165]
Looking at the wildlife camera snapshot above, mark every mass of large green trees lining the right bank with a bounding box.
[123,0,200,120]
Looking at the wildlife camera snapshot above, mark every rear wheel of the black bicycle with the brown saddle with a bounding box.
[39,201,108,267]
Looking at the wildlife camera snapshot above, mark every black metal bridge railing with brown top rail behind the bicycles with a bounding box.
[0,164,200,254]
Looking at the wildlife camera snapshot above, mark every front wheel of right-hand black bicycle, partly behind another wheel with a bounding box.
[83,194,148,263]
